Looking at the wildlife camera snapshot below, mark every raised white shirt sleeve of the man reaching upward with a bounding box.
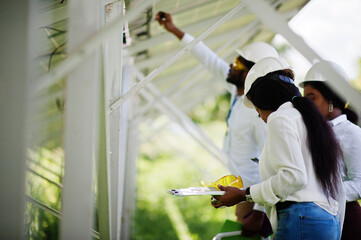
[181,33,236,93]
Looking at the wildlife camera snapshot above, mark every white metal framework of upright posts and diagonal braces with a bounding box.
[0,0,361,239]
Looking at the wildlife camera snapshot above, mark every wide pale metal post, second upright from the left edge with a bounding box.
[60,0,101,240]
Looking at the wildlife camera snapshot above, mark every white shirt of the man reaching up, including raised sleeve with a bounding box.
[181,33,266,187]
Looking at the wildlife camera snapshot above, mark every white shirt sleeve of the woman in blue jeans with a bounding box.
[250,116,307,205]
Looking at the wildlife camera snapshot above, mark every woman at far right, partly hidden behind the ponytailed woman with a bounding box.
[299,61,361,240]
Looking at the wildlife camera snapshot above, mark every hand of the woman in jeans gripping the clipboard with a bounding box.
[212,185,246,208]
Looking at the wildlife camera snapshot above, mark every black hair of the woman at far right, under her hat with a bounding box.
[305,81,358,124]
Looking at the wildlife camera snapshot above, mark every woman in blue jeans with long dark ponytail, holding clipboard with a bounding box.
[212,57,344,240]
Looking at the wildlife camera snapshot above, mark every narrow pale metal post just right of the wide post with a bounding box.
[102,1,124,239]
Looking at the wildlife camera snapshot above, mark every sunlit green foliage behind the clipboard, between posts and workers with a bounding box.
[132,122,235,240]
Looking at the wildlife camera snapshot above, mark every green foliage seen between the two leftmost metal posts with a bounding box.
[25,149,63,240]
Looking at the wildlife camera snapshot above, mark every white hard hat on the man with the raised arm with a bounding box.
[236,42,278,63]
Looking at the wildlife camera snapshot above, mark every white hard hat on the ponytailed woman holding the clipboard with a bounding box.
[243,57,291,108]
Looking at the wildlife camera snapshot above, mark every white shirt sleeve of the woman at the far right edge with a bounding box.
[341,124,361,201]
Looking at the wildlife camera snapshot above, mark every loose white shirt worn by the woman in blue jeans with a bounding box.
[250,102,344,232]
